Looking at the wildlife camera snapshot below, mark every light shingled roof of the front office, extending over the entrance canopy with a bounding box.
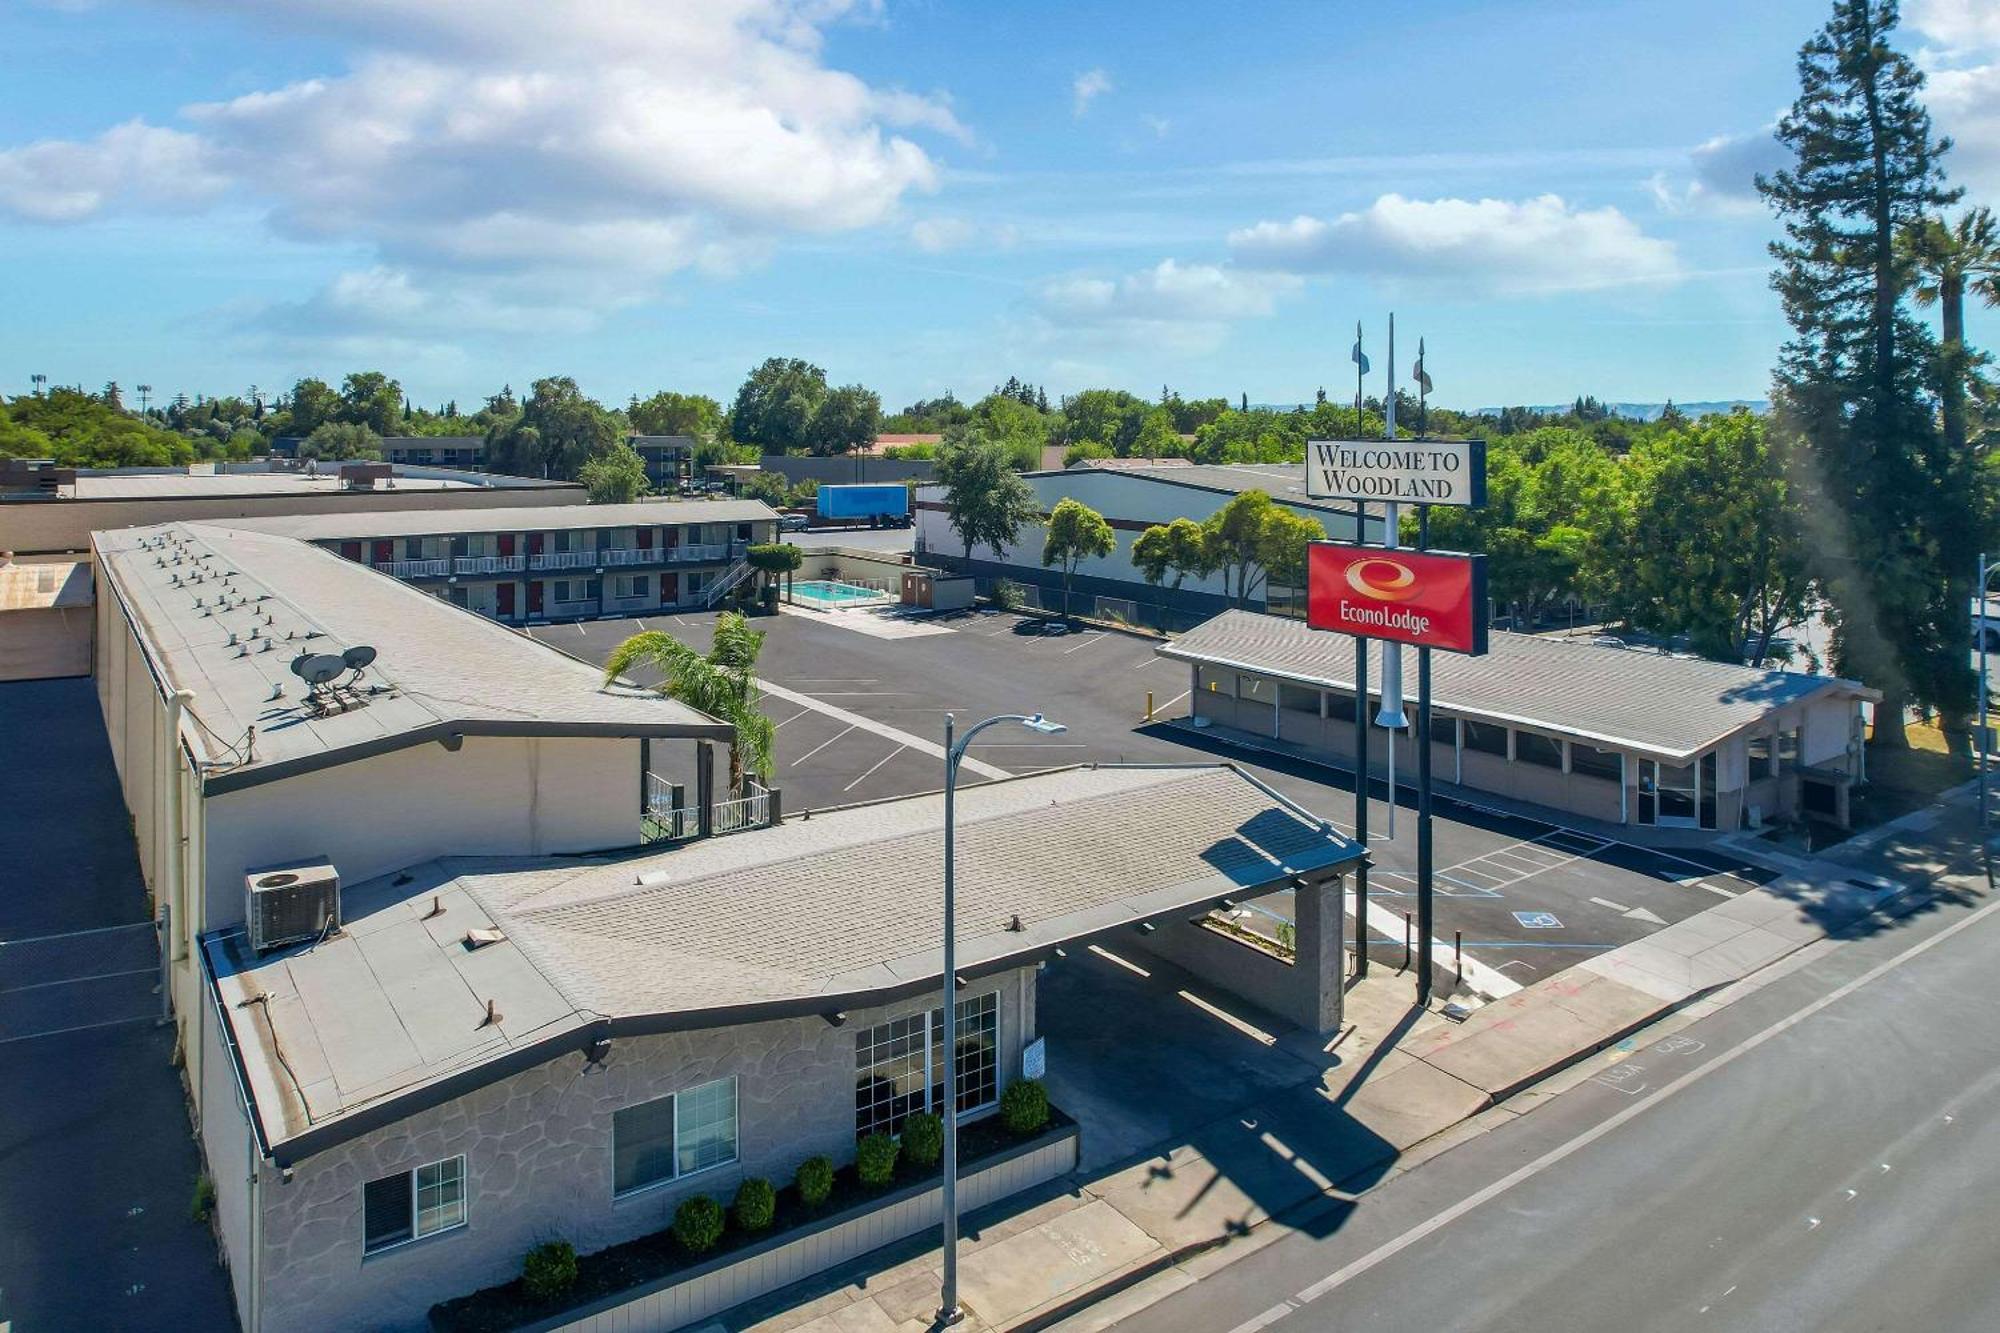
[204,765,1362,1161]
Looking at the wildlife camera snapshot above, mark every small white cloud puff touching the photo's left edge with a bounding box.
[0,120,228,222]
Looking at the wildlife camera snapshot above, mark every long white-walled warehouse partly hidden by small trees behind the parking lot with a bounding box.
[916,458,1382,628]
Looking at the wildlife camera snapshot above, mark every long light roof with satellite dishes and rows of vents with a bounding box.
[92,522,730,791]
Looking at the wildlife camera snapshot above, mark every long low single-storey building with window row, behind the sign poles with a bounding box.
[1158,610,1880,833]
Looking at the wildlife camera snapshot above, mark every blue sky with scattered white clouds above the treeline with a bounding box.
[0,0,2000,410]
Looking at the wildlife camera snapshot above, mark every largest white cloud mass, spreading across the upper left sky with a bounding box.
[0,0,968,334]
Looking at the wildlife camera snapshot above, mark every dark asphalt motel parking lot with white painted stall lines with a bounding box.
[532,612,1772,997]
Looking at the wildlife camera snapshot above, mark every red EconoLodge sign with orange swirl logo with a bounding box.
[1306,542,1486,656]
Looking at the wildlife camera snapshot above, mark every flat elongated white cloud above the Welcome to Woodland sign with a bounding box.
[1230,194,1680,294]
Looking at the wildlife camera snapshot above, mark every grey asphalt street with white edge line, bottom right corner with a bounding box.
[1118,852,2000,1333]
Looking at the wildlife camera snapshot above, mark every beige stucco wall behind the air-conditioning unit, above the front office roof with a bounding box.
[202,737,640,929]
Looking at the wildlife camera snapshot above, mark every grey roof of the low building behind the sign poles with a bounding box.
[1158,610,1880,763]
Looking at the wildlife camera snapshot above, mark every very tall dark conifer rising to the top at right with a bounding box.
[1758,0,1978,745]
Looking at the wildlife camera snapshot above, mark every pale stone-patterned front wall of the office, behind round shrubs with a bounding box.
[264,969,1034,1333]
